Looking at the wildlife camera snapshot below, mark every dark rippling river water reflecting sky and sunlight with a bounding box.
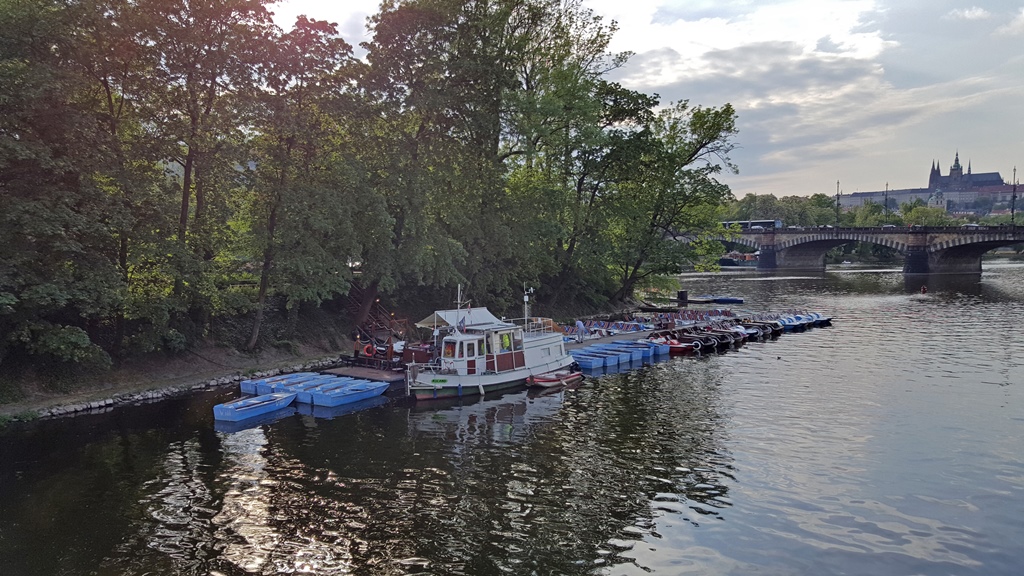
[0,262,1024,576]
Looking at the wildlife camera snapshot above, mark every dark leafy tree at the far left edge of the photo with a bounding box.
[0,2,123,364]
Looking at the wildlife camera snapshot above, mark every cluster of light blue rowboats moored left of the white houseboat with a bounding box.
[213,372,389,422]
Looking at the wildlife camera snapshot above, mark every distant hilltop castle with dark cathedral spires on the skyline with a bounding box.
[840,151,1014,212]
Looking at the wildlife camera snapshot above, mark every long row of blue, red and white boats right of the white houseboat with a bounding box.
[569,313,831,369]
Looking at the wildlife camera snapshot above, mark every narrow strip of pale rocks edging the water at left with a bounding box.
[25,356,350,418]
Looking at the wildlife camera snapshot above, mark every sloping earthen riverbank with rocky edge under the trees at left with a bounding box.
[0,342,351,425]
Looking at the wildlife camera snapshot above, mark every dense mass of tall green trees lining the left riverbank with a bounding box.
[0,0,737,364]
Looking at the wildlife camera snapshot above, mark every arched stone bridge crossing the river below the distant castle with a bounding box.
[719,225,1024,274]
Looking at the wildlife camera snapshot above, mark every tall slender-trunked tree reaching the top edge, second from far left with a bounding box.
[138,0,272,335]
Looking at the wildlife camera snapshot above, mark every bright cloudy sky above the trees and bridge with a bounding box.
[271,0,1024,198]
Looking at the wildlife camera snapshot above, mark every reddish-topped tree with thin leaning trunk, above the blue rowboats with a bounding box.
[240,17,358,349]
